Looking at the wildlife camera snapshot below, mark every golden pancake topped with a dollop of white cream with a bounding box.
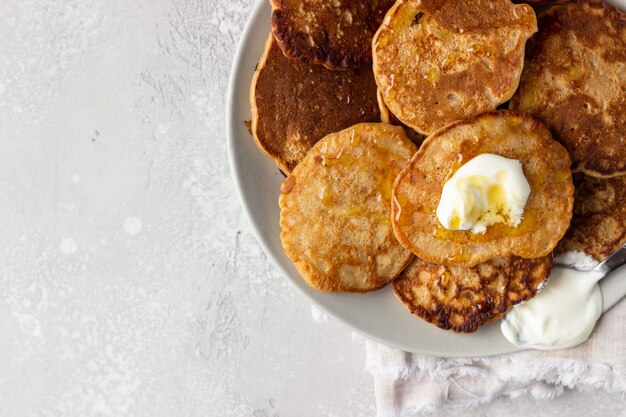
[391,110,574,267]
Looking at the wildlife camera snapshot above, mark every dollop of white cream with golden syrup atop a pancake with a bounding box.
[437,153,530,233]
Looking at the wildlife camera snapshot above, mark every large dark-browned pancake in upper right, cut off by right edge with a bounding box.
[511,1,626,177]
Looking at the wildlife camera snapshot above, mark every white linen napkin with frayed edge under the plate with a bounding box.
[366,302,626,417]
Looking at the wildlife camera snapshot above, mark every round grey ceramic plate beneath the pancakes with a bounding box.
[227,0,626,357]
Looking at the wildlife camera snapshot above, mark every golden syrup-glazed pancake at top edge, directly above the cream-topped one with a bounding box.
[373,0,537,134]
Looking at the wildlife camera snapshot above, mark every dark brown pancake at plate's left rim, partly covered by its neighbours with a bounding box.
[250,35,380,173]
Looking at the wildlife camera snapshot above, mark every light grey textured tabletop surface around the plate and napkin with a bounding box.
[0,0,626,417]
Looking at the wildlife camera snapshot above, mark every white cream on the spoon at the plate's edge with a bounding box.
[500,267,605,350]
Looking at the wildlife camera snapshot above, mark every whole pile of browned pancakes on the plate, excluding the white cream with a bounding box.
[250,0,626,332]
